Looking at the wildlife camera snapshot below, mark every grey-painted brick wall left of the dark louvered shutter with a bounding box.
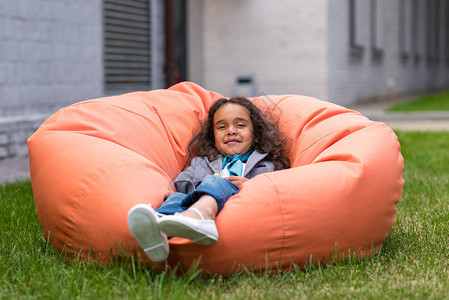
[0,0,103,158]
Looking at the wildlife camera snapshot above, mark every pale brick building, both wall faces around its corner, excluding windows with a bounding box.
[196,0,449,105]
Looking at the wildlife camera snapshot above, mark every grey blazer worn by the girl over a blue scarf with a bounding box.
[173,151,274,194]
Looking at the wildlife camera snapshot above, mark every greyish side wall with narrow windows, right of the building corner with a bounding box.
[326,0,449,105]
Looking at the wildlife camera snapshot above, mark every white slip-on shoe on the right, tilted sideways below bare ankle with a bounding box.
[159,208,218,245]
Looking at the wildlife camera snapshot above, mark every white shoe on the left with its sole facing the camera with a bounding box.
[128,204,169,262]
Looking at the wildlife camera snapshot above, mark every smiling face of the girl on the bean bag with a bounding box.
[213,103,254,156]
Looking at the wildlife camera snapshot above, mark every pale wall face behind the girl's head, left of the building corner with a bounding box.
[202,0,327,98]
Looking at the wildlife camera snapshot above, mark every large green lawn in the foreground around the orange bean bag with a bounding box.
[0,132,449,299]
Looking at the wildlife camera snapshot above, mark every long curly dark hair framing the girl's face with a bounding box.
[189,97,290,170]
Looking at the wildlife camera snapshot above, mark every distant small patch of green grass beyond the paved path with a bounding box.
[387,91,449,112]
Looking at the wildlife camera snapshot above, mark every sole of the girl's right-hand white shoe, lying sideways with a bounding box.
[159,216,217,245]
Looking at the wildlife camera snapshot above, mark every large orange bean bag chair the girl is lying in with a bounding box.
[28,82,404,274]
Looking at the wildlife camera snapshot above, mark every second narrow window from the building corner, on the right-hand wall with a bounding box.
[371,0,383,59]
